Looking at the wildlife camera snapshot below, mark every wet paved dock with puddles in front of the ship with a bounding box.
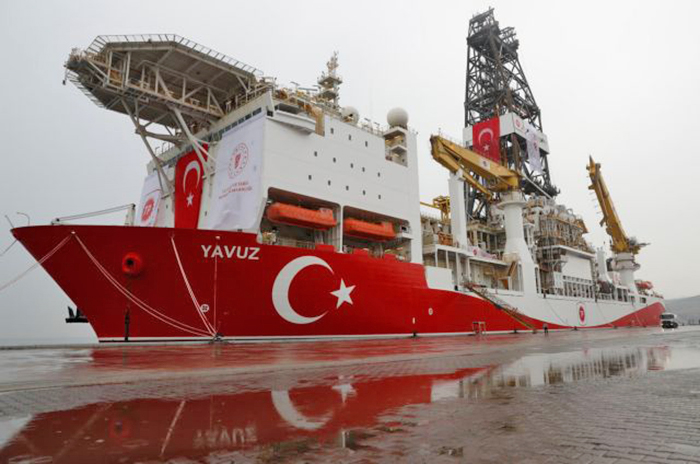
[0,329,700,463]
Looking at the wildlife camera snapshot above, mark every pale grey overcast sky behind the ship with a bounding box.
[0,0,700,339]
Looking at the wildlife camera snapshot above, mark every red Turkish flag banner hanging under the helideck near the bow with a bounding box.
[175,144,208,229]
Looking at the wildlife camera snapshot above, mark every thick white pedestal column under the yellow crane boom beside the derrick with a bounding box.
[499,192,537,293]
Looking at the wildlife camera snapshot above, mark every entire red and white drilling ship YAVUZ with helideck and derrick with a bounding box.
[13,9,664,342]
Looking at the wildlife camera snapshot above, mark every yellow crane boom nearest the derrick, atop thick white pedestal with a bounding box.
[430,135,520,200]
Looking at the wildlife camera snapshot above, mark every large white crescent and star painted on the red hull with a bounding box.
[272,256,355,324]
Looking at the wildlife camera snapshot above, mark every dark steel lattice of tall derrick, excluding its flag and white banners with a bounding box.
[464,8,559,218]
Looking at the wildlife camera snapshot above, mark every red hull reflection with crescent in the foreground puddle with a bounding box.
[0,368,488,463]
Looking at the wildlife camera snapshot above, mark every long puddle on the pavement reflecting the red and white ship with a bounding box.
[0,347,700,463]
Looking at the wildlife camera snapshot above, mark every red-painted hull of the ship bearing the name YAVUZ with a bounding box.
[13,226,663,341]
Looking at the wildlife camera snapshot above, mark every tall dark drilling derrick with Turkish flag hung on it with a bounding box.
[464,8,559,219]
